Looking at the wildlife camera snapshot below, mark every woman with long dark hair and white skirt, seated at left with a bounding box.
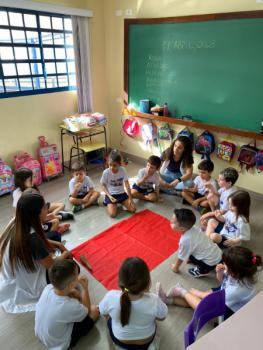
[0,193,70,313]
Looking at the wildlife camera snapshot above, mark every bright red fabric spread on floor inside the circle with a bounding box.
[71,209,180,289]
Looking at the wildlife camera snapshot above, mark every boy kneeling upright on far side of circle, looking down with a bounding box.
[100,150,136,218]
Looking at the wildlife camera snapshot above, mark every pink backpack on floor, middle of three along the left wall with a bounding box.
[14,152,42,186]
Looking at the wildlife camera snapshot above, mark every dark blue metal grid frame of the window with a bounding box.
[0,6,77,99]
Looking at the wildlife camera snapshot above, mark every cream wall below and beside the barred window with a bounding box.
[0,0,107,164]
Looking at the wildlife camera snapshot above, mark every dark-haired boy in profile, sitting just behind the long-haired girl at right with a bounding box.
[200,167,241,233]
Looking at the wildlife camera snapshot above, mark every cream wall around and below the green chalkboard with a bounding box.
[104,0,263,194]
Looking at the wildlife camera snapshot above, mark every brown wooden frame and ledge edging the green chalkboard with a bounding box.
[124,10,263,140]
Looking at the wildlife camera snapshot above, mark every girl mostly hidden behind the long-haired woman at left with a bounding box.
[13,167,74,233]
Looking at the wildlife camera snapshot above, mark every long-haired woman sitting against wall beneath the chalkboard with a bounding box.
[160,136,194,194]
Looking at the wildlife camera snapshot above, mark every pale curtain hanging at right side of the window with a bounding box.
[72,16,93,113]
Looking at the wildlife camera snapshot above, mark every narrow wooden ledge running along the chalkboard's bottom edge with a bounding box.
[136,111,263,140]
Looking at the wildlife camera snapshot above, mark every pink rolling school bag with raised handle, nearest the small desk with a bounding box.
[38,136,62,180]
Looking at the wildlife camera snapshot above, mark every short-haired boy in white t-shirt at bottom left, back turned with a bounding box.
[35,259,99,350]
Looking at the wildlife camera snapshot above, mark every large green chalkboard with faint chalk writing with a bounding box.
[125,11,263,132]
